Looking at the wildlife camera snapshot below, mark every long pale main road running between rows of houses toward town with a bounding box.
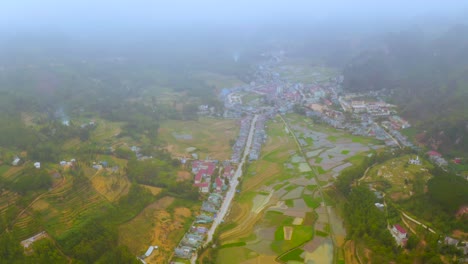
[190,115,258,263]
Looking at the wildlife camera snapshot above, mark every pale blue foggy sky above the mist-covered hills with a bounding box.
[0,0,468,33]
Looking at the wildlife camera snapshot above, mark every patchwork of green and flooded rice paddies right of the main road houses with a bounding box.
[217,115,379,263]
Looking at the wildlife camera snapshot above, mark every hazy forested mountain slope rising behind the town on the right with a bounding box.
[344,25,468,155]
